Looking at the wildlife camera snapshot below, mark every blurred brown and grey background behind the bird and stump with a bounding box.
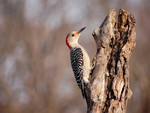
[0,0,150,113]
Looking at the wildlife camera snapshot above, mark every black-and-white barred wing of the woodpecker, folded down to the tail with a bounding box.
[70,47,86,98]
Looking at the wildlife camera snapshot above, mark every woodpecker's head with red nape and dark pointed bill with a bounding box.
[66,27,85,49]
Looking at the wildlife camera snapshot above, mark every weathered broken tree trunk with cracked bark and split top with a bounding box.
[87,9,136,113]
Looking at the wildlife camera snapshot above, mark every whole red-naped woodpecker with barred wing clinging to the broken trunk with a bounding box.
[66,27,91,98]
